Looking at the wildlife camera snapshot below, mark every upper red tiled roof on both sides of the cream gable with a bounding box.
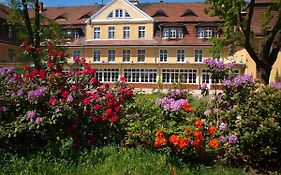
[30,2,218,25]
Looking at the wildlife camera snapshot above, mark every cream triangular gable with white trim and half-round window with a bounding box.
[86,0,154,24]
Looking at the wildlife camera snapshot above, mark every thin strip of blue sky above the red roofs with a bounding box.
[0,0,204,7]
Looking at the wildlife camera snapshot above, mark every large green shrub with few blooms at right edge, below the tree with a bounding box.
[220,85,281,168]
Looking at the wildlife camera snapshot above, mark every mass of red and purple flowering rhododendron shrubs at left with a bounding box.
[0,46,133,150]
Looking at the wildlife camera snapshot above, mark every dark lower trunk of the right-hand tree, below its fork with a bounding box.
[256,63,272,84]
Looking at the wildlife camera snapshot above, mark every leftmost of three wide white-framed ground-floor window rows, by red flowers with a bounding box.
[96,69,119,83]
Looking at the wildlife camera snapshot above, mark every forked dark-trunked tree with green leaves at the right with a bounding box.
[205,0,281,84]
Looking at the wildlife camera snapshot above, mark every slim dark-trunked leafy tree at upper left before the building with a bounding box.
[6,0,64,68]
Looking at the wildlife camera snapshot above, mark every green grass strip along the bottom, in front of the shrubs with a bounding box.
[0,147,244,175]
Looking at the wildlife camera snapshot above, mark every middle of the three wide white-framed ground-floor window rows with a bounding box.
[124,69,157,83]
